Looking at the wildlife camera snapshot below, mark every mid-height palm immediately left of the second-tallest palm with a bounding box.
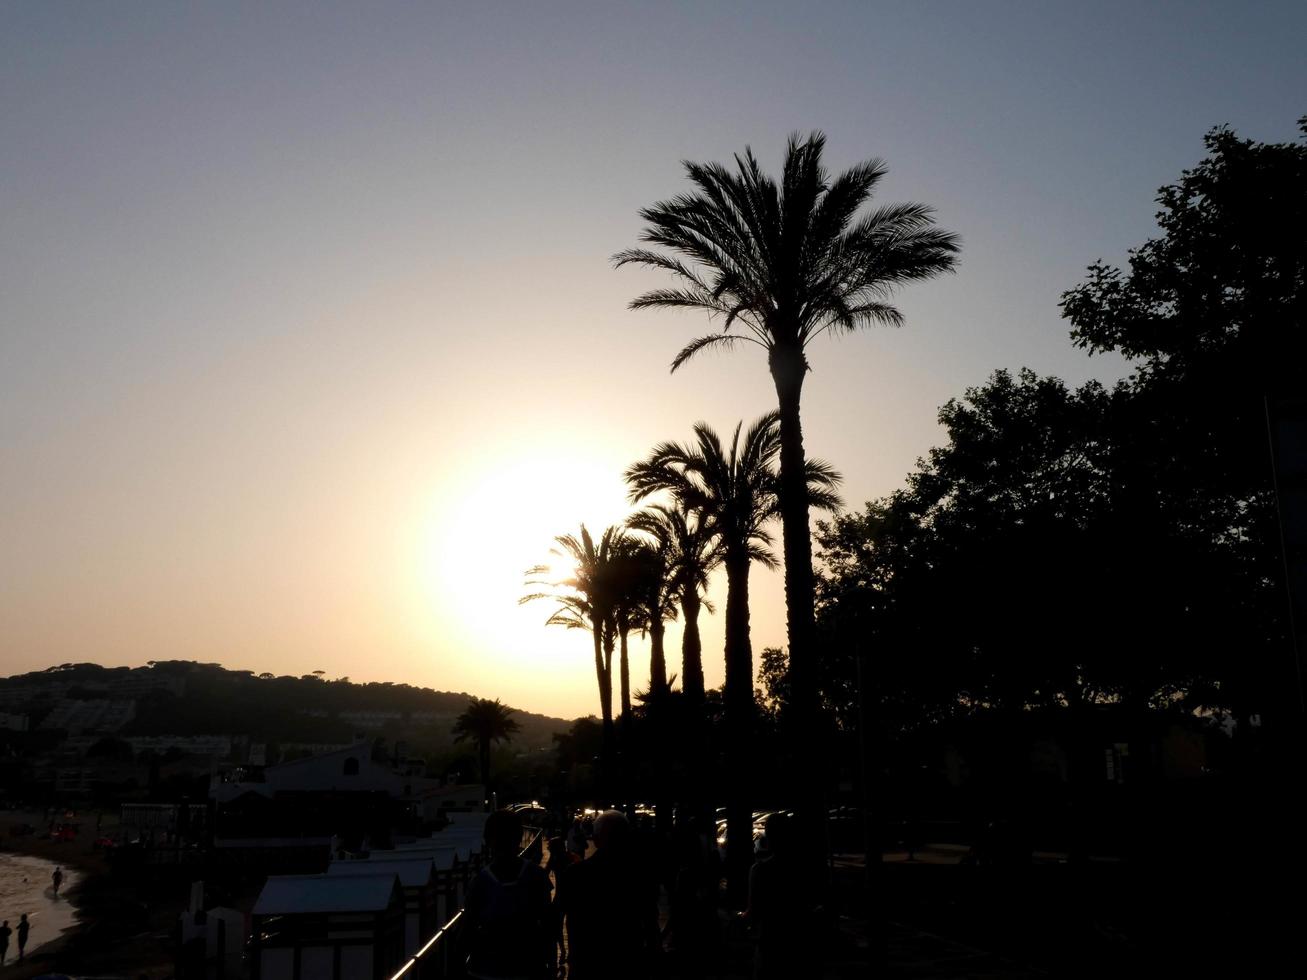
[626,506,721,710]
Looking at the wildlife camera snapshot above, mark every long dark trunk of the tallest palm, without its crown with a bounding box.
[769,344,826,865]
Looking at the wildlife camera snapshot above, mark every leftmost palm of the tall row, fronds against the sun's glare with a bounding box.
[518,524,625,767]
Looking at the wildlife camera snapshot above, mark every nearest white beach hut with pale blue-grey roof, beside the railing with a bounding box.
[250,872,405,980]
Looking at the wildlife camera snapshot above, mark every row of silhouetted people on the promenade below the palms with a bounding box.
[465,810,805,980]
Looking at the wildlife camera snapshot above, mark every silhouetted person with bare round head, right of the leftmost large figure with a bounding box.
[554,810,659,980]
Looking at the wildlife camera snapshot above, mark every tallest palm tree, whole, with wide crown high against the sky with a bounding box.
[613,132,958,836]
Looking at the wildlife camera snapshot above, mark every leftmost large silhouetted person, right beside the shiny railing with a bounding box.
[467,810,558,980]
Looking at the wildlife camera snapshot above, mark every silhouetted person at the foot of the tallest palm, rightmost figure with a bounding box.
[744,813,814,980]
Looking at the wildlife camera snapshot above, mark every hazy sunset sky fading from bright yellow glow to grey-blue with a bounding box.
[0,0,1307,717]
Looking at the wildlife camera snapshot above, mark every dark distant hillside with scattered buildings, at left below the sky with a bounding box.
[0,661,570,805]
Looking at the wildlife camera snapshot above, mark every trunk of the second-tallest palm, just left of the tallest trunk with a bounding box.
[724,553,753,908]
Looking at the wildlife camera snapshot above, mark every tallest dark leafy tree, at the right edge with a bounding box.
[1061,116,1307,736]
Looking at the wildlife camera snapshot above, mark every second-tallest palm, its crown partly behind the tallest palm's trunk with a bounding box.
[626,412,839,903]
